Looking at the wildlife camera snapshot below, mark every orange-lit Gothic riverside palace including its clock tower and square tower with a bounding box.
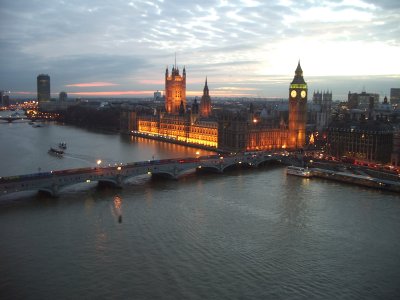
[121,62,308,152]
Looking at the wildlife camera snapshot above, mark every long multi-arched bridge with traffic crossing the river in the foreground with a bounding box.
[0,152,286,196]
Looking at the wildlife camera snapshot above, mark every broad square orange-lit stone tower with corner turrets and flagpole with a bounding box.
[165,65,186,114]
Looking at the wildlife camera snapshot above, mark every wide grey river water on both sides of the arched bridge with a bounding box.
[0,114,400,299]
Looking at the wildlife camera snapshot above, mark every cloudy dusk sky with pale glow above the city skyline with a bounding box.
[0,0,400,100]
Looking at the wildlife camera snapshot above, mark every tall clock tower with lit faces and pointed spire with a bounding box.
[288,61,308,148]
